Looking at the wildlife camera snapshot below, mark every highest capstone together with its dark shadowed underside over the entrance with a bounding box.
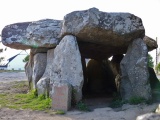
[61,8,145,58]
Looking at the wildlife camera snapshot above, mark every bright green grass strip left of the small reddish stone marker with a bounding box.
[0,91,51,110]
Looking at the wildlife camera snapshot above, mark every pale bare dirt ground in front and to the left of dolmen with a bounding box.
[0,72,158,120]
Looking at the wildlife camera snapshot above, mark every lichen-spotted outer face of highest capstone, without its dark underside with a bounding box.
[61,8,144,40]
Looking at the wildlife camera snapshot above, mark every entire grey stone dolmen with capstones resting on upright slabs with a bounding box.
[2,8,158,111]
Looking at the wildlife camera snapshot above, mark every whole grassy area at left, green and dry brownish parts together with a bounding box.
[0,81,65,115]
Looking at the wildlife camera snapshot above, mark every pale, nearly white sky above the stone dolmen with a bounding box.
[0,0,160,61]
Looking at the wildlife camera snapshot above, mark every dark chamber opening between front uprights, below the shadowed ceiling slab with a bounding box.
[82,55,123,110]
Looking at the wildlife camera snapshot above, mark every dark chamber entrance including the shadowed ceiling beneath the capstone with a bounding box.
[78,41,124,109]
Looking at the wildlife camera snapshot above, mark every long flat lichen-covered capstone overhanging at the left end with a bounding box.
[2,19,61,49]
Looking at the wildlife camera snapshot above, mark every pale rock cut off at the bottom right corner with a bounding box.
[136,113,160,120]
